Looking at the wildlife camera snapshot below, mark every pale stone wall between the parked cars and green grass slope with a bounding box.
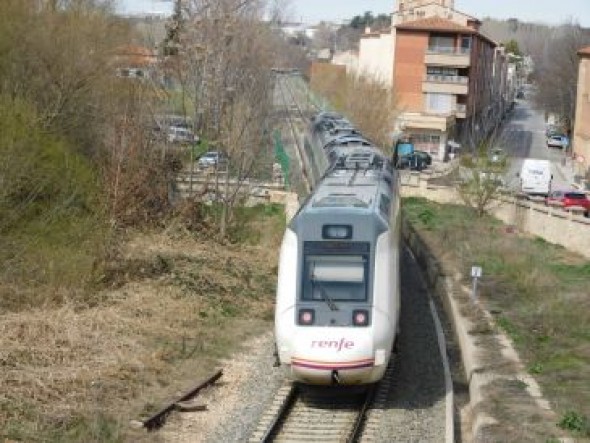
[402,181,590,258]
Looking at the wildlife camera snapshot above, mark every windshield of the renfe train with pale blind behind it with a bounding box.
[302,255,368,302]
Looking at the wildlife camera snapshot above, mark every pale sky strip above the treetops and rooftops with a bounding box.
[116,0,590,28]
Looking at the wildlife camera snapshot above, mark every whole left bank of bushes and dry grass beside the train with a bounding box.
[0,0,284,442]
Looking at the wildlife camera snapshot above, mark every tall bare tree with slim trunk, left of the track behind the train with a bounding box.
[169,0,282,237]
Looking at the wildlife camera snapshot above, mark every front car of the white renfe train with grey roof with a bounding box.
[275,149,400,385]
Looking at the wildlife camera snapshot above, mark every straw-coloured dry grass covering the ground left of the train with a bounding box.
[0,224,277,441]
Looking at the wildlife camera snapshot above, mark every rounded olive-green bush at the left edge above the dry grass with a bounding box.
[0,97,108,309]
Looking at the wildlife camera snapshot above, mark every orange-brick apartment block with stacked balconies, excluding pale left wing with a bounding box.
[394,14,507,160]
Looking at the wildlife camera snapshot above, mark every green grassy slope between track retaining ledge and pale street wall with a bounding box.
[403,198,590,435]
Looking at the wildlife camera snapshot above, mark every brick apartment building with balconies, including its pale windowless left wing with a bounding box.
[359,0,517,160]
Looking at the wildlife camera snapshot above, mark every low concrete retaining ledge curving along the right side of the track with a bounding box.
[402,215,580,442]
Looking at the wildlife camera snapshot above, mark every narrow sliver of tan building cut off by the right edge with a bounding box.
[573,46,590,178]
